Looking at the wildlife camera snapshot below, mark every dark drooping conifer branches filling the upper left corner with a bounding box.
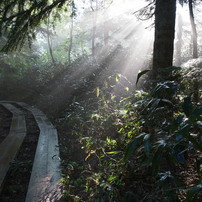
[0,0,71,51]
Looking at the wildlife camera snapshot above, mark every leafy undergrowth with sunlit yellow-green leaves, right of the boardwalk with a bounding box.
[62,67,202,201]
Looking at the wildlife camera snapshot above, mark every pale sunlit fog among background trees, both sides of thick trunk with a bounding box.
[1,0,202,105]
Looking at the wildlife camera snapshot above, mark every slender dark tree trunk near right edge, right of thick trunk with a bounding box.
[189,0,198,58]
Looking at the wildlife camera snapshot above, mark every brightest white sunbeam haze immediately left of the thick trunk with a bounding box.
[76,0,154,79]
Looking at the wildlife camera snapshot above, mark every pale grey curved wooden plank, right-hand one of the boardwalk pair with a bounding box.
[18,103,61,202]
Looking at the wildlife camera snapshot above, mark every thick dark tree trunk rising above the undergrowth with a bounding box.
[153,0,176,78]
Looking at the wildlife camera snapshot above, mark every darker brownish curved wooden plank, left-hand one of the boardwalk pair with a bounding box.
[0,103,26,190]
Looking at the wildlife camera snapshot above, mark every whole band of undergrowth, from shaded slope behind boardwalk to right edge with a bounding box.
[0,53,202,202]
